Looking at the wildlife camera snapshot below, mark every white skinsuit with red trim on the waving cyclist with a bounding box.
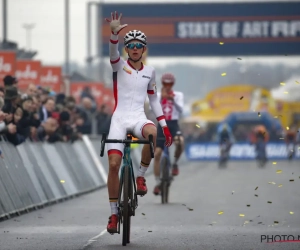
[107,34,166,155]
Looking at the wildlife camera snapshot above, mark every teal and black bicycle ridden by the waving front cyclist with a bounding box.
[100,134,154,246]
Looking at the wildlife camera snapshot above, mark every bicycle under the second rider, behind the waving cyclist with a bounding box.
[158,133,180,204]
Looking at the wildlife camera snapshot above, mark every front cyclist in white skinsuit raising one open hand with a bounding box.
[106,12,172,234]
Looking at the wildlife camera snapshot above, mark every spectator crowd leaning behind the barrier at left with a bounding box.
[0,75,111,146]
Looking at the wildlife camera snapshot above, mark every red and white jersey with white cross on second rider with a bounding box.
[157,91,184,121]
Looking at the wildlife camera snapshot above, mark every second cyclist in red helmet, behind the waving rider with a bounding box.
[153,73,184,195]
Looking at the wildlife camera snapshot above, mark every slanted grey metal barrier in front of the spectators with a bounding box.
[0,136,107,218]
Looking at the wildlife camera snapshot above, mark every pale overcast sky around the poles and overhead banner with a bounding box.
[0,0,300,66]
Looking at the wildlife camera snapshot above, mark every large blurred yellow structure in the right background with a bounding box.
[191,85,300,127]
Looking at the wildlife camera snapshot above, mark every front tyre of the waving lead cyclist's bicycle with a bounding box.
[122,166,129,246]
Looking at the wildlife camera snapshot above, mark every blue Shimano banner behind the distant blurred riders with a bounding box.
[185,143,300,161]
